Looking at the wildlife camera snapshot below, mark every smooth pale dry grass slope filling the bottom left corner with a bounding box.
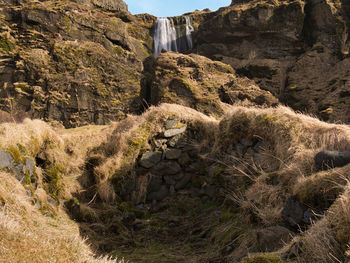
[0,172,120,263]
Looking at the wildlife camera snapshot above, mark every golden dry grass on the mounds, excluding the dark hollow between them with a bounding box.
[0,104,350,262]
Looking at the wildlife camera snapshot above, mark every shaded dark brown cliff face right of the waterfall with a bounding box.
[196,0,350,122]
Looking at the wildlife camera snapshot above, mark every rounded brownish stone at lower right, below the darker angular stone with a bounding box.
[256,226,294,252]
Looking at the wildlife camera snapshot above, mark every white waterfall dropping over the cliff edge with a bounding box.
[153,16,194,57]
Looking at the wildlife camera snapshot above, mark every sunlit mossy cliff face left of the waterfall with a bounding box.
[0,0,153,127]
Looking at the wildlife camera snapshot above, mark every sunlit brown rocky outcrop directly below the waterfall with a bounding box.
[142,52,278,116]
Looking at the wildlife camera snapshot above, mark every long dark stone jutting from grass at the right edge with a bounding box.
[314,150,350,170]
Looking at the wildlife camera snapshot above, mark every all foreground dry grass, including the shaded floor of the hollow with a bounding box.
[0,104,350,262]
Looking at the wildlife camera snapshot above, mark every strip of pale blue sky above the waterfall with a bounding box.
[124,0,231,16]
